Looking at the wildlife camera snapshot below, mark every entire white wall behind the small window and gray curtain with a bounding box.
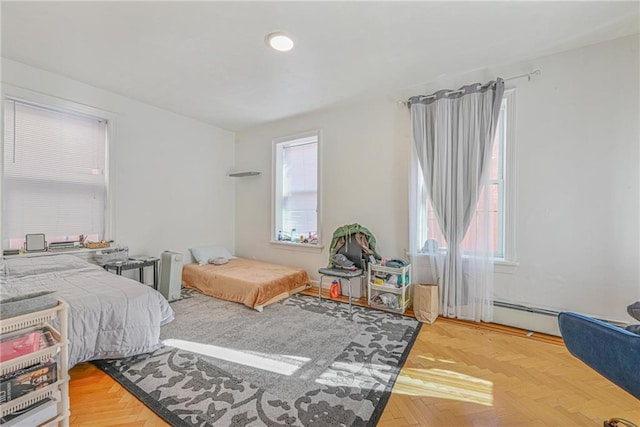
[236,36,640,321]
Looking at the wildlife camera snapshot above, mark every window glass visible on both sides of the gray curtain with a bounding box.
[411,91,515,261]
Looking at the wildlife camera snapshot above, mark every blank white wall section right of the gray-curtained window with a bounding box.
[496,35,640,321]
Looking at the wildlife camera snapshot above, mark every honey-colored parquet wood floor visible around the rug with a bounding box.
[70,292,640,427]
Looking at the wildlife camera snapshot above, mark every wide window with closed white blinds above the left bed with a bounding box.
[2,98,107,249]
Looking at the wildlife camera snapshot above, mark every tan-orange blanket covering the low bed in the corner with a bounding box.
[182,258,310,308]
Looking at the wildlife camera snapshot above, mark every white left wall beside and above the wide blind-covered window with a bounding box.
[2,58,234,260]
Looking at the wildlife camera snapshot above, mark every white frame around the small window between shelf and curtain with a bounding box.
[270,129,324,252]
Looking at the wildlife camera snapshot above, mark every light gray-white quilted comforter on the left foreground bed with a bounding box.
[0,255,173,368]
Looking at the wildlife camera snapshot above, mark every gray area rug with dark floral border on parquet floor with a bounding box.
[94,291,420,426]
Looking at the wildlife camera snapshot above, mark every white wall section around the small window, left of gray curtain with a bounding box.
[236,99,409,277]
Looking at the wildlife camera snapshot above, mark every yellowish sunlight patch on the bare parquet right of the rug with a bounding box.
[393,368,493,406]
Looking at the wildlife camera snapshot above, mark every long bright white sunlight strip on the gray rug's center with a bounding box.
[162,338,311,376]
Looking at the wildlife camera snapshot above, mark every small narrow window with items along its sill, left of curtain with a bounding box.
[272,131,320,245]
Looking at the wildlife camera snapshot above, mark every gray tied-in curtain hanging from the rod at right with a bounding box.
[409,78,504,321]
